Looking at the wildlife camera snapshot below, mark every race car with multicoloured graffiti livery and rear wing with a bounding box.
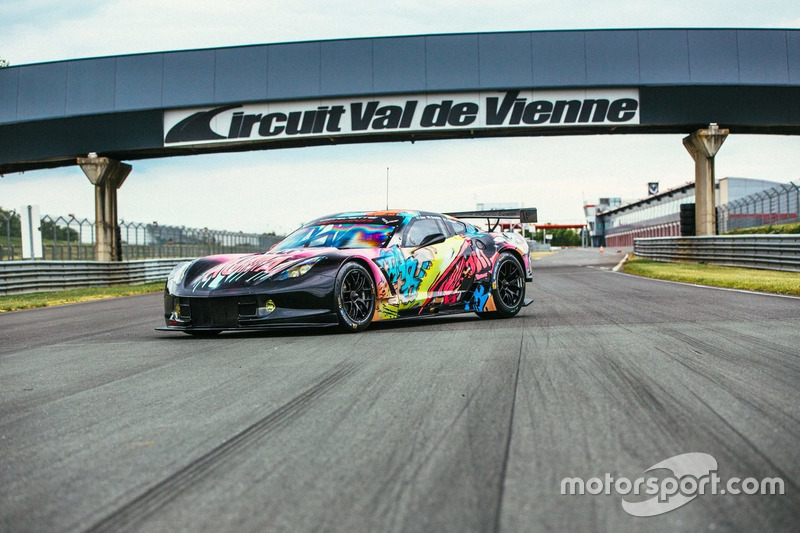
[157,209,536,335]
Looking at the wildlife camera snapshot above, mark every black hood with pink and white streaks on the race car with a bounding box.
[179,248,338,292]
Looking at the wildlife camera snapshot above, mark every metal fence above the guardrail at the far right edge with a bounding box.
[718,183,800,233]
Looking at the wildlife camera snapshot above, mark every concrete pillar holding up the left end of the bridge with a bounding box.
[78,154,132,261]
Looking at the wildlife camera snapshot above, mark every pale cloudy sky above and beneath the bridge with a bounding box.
[0,0,800,233]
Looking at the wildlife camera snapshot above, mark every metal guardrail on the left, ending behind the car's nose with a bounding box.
[0,258,190,294]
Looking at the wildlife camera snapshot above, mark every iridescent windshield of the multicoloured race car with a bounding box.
[273,222,397,250]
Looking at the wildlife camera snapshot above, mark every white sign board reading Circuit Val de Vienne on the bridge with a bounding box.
[164,89,639,146]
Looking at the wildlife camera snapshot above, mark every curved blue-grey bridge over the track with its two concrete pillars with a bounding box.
[0,29,800,260]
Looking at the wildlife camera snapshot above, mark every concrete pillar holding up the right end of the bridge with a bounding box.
[683,124,729,235]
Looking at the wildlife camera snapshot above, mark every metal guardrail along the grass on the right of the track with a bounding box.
[633,235,800,272]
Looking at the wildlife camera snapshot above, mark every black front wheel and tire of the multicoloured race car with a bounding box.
[333,262,376,333]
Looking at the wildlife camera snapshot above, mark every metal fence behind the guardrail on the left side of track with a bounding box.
[0,210,282,261]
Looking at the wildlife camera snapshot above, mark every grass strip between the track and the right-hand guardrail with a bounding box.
[622,258,800,296]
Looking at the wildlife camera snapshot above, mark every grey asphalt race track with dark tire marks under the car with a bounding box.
[0,250,800,532]
